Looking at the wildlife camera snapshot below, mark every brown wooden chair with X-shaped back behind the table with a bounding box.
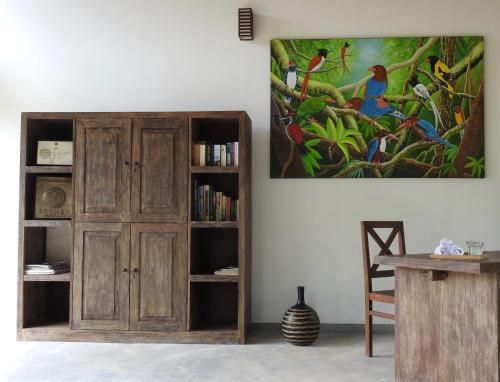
[361,221,406,357]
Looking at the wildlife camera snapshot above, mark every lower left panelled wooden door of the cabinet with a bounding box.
[72,223,130,330]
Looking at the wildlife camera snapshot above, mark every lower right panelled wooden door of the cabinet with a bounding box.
[130,224,187,331]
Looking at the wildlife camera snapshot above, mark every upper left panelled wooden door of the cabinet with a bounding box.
[75,118,131,222]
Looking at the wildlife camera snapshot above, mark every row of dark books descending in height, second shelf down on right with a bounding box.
[193,180,238,221]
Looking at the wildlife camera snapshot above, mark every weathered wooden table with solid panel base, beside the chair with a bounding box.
[374,251,500,382]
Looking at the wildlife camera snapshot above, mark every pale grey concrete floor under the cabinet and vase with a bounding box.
[0,330,394,382]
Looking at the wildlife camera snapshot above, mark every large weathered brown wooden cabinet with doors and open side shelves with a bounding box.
[17,111,251,343]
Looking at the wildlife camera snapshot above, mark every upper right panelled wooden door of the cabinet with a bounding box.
[132,118,188,223]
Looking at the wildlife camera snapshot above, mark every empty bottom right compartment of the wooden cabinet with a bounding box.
[190,282,238,331]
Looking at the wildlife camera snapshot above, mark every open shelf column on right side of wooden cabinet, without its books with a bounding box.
[188,114,251,342]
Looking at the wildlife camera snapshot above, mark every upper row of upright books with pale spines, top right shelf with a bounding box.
[193,142,238,167]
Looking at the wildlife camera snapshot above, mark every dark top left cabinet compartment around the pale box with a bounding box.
[26,118,73,166]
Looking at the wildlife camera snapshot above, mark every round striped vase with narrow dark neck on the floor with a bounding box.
[281,286,319,346]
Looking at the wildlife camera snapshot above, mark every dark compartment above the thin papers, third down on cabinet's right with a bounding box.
[190,228,238,276]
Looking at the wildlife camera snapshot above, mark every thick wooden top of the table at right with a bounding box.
[373,251,500,274]
